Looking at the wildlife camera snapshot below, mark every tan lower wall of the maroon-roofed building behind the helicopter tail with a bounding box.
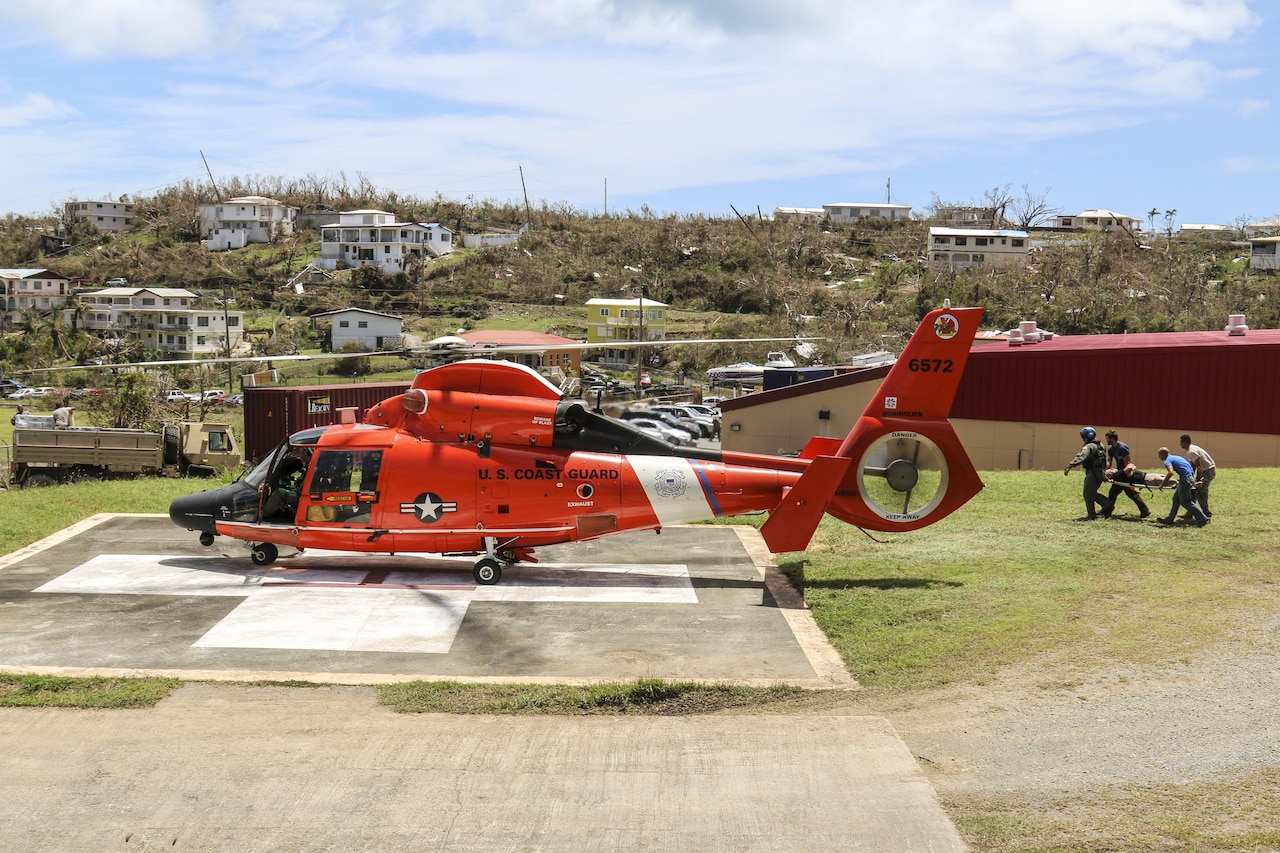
[721,380,1280,471]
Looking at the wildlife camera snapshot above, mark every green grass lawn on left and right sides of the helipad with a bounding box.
[0,469,1280,693]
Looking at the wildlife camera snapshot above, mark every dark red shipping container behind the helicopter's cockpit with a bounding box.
[244,380,410,460]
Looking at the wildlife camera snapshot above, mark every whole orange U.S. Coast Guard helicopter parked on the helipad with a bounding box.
[169,307,983,584]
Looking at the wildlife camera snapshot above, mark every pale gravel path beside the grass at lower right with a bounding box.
[884,621,1280,799]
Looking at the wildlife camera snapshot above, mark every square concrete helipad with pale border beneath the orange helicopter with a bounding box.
[0,515,852,686]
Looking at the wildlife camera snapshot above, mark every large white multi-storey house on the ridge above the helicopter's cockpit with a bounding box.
[317,210,453,273]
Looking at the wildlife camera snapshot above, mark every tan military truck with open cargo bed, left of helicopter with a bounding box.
[9,415,242,488]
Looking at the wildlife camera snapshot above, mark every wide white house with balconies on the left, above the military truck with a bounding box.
[77,287,244,356]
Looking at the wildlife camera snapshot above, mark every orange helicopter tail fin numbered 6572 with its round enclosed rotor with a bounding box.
[760,309,982,553]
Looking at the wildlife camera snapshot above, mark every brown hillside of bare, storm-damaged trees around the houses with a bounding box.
[0,177,1280,373]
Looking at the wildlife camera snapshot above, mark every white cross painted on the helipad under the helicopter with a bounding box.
[35,551,698,654]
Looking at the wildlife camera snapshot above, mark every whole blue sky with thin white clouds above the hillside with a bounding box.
[0,0,1280,225]
